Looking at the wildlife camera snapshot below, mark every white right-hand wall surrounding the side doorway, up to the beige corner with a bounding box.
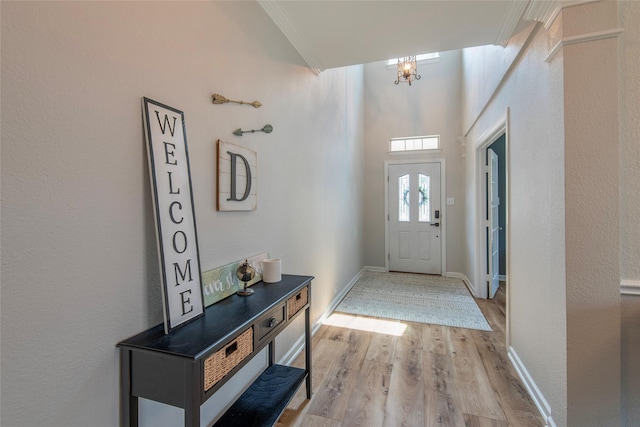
[463,25,566,425]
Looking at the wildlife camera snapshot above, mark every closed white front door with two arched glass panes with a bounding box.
[387,163,442,274]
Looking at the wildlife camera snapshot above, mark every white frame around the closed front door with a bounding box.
[384,158,447,276]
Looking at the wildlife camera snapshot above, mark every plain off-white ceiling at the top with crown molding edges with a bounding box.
[257,0,559,73]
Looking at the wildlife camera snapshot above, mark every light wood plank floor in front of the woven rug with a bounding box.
[277,284,545,427]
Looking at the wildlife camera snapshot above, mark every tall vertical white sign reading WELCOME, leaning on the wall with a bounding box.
[142,98,204,333]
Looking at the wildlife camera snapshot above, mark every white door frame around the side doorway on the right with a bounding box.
[473,108,511,348]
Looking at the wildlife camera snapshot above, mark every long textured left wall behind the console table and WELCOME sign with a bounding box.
[1,2,364,427]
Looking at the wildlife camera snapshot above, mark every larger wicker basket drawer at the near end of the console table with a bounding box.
[204,328,253,391]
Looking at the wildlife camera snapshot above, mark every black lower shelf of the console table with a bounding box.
[214,365,306,427]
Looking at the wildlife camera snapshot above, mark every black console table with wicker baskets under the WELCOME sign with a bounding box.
[117,274,313,427]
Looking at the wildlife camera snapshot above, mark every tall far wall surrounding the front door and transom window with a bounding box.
[364,51,465,273]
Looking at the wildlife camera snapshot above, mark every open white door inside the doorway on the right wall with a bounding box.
[487,148,500,298]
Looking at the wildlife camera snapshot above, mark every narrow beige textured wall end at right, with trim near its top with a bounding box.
[562,2,621,427]
